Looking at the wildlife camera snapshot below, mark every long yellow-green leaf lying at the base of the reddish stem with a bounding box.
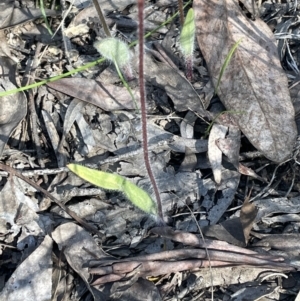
[67,164,157,215]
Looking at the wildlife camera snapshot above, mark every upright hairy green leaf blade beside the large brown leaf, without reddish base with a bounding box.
[180,8,196,57]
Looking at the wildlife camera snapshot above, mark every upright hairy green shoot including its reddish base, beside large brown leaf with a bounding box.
[180,8,196,81]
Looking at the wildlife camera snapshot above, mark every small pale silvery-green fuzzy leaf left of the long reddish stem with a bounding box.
[94,38,130,68]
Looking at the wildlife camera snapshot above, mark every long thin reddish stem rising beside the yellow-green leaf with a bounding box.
[137,0,163,222]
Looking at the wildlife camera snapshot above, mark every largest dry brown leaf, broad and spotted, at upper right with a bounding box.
[194,0,297,162]
